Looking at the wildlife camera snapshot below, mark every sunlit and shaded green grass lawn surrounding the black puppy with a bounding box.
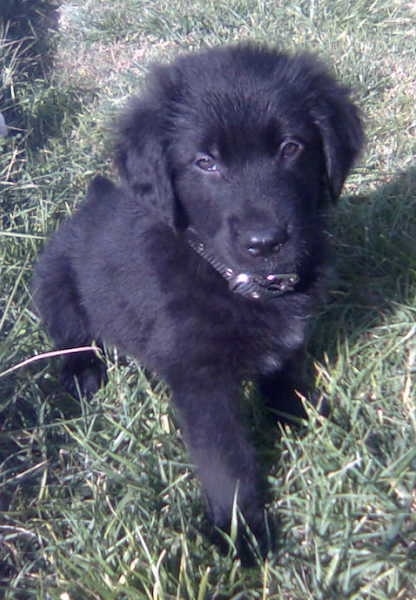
[0,0,416,600]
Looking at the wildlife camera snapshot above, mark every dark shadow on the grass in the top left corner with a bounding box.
[0,0,88,150]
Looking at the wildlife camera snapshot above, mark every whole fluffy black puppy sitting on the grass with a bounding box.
[34,46,363,556]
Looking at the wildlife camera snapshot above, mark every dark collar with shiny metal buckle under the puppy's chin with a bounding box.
[185,227,299,300]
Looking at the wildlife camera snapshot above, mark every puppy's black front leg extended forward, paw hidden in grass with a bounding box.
[172,371,269,565]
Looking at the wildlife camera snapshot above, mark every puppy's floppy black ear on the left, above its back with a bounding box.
[115,98,175,226]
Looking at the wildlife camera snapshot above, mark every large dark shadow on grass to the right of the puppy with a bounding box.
[311,168,416,360]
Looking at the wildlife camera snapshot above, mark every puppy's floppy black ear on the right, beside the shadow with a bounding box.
[312,84,364,201]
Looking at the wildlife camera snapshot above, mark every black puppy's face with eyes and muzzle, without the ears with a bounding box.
[171,94,325,297]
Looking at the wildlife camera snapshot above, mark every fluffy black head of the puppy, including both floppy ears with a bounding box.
[118,46,363,298]
